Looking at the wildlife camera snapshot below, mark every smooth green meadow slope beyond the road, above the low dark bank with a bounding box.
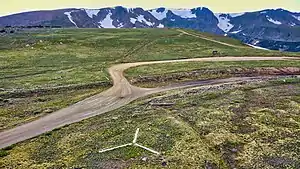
[0,29,297,90]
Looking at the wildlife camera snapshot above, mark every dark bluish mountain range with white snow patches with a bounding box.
[0,6,300,52]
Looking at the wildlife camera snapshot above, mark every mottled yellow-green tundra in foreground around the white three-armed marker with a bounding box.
[0,79,300,168]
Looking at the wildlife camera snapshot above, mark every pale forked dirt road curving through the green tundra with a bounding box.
[0,57,295,148]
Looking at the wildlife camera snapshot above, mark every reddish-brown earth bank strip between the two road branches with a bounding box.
[130,67,300,84]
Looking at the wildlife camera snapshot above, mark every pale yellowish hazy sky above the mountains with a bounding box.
[0,0,300,16]
